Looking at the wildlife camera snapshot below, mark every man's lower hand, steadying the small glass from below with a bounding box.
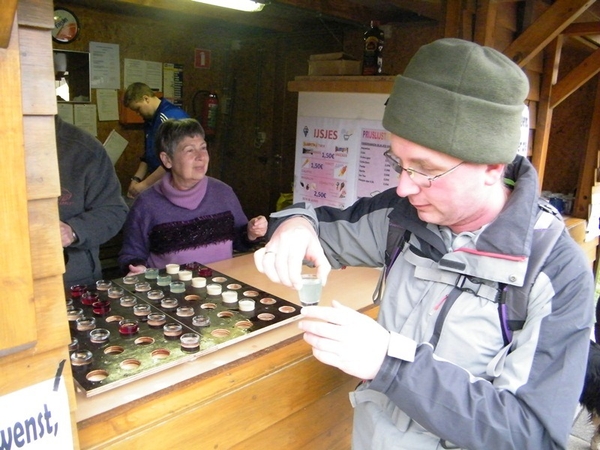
[298,300,390,380]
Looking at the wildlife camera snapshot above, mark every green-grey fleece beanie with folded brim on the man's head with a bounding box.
[383,39,529,164]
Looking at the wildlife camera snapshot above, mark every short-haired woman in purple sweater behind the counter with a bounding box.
[119,119,267,274]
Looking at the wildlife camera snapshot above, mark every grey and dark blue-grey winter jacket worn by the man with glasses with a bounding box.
[270,157,594,450]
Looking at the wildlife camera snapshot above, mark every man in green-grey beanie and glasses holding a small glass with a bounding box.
[255,39,594,450]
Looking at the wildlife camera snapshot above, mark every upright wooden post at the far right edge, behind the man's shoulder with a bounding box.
[572,80,600,219]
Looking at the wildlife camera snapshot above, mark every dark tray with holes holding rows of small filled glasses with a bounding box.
[67,263,300,397]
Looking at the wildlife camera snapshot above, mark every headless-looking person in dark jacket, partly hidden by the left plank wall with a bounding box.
[55,115,127,289]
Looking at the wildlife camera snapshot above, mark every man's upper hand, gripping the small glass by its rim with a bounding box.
[254,217,331,290]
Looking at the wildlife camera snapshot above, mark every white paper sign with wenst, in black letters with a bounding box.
[0,377,73,450]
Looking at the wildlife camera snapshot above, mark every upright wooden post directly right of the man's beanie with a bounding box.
[531,36,563,189]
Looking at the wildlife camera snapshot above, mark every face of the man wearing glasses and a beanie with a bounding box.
[391,135,503,233]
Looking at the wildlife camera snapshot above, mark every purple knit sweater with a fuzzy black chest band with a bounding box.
[119,173,248,272]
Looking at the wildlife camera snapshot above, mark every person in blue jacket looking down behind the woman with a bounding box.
[123,82,189,198]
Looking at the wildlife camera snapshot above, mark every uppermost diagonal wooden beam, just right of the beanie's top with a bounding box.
[504,0,596,67]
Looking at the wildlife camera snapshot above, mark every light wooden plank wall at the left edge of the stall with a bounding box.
[0,0,78,442]
